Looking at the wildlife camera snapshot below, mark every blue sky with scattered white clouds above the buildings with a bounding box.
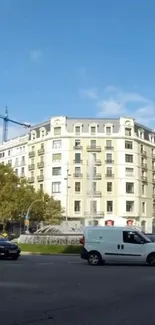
[0,0,155,135]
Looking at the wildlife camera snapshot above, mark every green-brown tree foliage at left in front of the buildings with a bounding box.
[0,164,63,224]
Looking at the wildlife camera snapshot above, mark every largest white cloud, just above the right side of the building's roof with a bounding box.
[80,86,155,126]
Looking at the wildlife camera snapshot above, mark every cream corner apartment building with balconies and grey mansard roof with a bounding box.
[0,116,155,232]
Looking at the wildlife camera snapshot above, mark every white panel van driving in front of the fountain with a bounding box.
[80,227,155,266]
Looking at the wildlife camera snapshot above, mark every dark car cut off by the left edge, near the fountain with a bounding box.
[0,238,21,260]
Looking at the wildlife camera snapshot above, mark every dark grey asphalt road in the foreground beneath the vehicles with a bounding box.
[0,256,155,325]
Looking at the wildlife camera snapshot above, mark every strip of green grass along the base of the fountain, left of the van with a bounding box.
[19,244,81,254]
